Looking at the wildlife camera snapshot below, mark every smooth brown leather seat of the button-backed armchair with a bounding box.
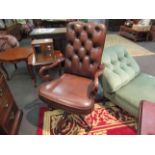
[39,74,94,113]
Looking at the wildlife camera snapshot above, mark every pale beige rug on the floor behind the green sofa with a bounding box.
[105,34,155,56]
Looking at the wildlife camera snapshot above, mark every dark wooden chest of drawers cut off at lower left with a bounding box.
[0,71,23,135]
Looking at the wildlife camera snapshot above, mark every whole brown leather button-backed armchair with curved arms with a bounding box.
[39,21,106,134]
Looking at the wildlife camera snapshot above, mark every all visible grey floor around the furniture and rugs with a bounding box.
[6,39,155,135]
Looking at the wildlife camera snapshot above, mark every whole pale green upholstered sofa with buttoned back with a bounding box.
[101,45,155,117]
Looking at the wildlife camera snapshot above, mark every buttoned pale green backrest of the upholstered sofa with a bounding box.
[102,45,140,92]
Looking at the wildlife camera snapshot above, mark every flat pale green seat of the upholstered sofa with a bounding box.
[114,73,155,116]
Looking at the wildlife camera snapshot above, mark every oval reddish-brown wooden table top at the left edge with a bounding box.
[0,47,33,62]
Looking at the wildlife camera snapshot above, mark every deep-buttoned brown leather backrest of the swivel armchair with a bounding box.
[65,21,106,78]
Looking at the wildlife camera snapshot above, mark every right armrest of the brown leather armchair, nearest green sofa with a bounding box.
[91,64,104,96]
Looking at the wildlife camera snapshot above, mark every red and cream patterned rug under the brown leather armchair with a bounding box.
[37,102,137,135]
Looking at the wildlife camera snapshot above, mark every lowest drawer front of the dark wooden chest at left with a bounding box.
[4,104,18,133]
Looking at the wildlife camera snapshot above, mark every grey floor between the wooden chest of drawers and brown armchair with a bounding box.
[7,62,46,135]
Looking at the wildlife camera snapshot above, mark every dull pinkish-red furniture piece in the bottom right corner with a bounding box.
[138,101,155,135]
